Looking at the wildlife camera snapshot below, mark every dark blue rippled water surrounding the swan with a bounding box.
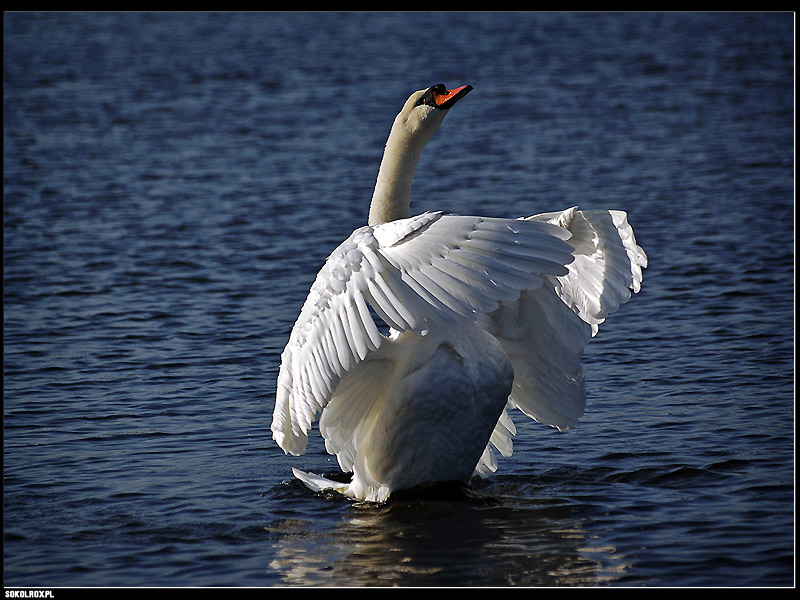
[3,13,795,586]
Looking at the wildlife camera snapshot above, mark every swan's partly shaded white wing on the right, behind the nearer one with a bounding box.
[476,208,647,475]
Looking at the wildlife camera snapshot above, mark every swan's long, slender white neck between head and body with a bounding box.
[369,116,436,225]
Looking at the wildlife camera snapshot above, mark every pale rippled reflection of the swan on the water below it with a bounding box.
[268,476,635,586]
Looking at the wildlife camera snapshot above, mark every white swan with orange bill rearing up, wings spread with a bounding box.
[271,84,647,502]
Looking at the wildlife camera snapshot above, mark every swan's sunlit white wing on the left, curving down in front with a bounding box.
[272,213,573,454]
